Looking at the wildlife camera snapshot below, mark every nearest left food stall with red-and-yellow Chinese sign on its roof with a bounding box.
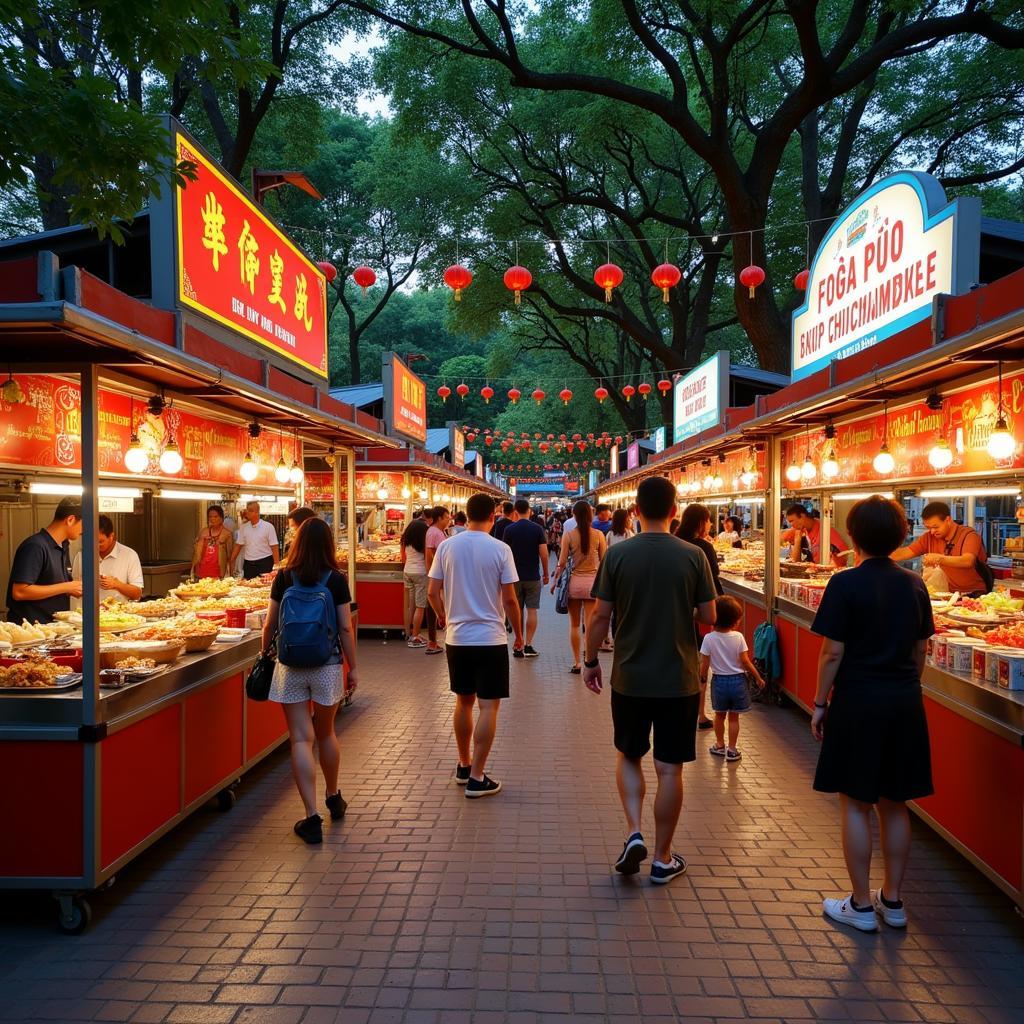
[0,117,392,933]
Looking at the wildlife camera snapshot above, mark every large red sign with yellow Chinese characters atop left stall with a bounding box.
[175,134,328,379]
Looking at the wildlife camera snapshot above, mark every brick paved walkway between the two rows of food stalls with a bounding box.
[0,598,1024,1024]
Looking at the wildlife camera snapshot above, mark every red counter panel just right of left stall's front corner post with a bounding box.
[99,705,181,867]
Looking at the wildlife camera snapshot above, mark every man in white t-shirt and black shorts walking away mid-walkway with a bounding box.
[427,495,522,799]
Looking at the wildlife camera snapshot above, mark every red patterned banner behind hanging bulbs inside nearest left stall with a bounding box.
[0,374,302,487]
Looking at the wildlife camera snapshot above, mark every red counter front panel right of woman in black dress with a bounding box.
[916,697,1024,890]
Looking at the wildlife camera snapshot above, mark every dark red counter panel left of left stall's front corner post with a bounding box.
[0,741,85,878]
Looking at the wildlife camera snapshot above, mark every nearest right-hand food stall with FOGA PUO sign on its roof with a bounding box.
[600,174,1024,905]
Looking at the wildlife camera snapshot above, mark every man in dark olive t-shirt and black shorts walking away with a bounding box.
[584,476,715,885]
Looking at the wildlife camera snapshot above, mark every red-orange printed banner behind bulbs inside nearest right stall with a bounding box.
[782,373,1024,484]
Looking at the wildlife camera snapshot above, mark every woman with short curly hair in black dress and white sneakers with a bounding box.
[811,495,935,932]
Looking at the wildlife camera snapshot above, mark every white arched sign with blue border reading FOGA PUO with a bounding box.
[792,171,981,380]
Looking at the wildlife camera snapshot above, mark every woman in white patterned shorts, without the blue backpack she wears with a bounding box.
[263,519,356,844]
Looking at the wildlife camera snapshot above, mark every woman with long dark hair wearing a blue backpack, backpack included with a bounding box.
[263,519,356,844]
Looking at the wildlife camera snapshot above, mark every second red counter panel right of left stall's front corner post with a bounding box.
[184,672,245,805]
